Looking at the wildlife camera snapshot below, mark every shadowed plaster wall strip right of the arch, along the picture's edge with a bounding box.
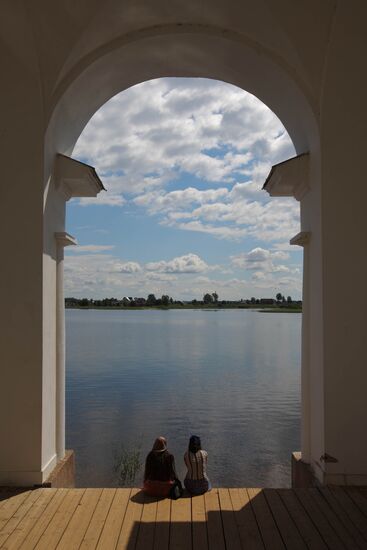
[321,1,367,483]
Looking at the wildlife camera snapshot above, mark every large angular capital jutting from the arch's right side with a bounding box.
[263,153,310,201]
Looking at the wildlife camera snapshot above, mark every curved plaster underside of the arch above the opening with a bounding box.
[47,26,318,166]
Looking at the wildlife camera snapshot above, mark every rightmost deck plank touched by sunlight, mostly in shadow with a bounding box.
[247,489,284,550]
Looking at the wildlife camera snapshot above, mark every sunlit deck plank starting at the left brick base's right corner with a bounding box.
[35,489,85,550]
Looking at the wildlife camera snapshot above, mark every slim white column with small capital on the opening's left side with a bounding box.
[55,233,76,460]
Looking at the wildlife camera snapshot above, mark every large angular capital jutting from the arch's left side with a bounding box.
[53,154,106,201]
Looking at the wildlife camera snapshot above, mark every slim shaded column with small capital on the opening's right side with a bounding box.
[290,231,311,464]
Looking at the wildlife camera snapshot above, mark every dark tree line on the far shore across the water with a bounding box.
[65,292,302,308]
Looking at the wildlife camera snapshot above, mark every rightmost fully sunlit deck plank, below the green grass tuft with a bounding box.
[97,489,131,550]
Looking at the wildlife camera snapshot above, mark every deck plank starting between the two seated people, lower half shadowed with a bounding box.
[169,497,192,550]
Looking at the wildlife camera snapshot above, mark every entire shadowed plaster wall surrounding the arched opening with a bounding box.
[0,0,367,484]
